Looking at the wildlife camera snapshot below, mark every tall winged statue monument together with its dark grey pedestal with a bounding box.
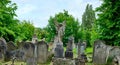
[53,20,65,58]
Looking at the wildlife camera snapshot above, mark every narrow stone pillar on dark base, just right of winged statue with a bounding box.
[65,37,74,58]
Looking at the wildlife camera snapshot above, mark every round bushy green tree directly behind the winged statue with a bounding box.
[47,10,80,45]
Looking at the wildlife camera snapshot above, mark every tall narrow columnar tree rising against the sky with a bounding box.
[81,4,96,46]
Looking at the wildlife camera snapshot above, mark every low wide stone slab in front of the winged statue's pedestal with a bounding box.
[53,58,75,65]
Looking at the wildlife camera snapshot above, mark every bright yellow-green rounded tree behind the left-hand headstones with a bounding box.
[16,20,35,41]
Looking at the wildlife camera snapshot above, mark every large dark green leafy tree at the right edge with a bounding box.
[96,0,120,45]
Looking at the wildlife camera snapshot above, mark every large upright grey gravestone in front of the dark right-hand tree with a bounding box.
[93,40,107,65]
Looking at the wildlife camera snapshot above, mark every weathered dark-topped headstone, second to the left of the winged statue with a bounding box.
[21,42,36,65]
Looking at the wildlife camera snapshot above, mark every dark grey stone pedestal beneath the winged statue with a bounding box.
[54,45,64,58]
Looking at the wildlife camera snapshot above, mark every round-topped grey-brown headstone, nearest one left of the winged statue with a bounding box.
[36,41,48,63]
